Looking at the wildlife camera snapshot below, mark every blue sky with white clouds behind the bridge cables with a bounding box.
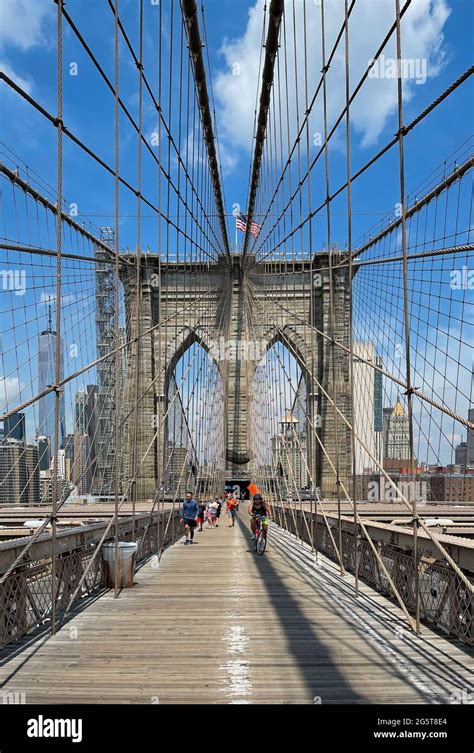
[0,0,474,464]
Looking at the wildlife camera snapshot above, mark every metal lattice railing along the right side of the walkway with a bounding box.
[275,506,474,646]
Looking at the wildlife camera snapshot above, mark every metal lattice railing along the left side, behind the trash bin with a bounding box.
[0,512,180,646]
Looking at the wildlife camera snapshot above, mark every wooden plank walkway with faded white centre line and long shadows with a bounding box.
[0,514,473,704]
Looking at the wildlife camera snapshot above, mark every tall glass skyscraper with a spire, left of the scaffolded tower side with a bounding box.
[36,306,66,445]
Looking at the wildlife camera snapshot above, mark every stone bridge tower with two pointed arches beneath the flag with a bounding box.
[121,252,352,499]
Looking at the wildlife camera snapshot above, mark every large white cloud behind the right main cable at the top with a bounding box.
[215,0,450,170]
